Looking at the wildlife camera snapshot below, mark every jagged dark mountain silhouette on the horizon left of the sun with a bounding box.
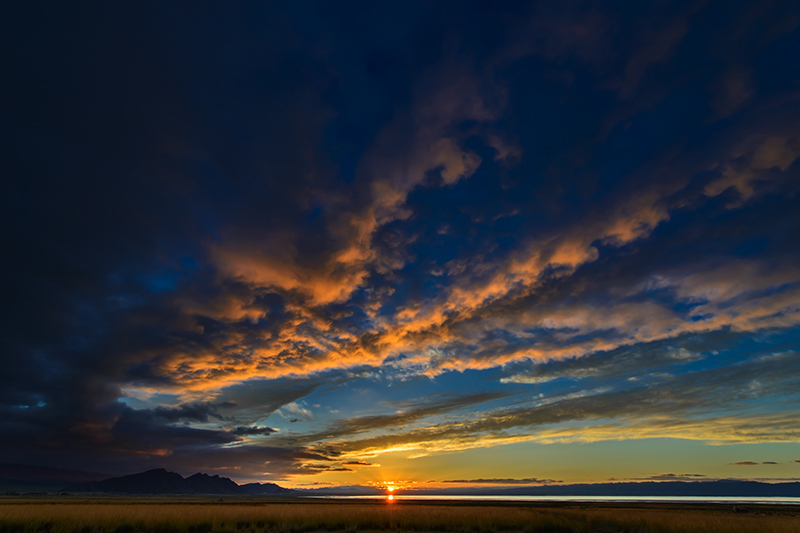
[63,468,293,496]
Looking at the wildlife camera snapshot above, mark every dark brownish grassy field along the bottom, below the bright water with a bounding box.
[0,498,800,533]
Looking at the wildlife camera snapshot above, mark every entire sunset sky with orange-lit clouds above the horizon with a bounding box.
[0,0,800,487]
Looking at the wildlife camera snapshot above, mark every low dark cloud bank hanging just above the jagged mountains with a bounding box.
[4,394,336,481]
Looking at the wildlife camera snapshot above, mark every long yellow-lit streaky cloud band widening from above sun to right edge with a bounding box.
[300,352,800,455]
